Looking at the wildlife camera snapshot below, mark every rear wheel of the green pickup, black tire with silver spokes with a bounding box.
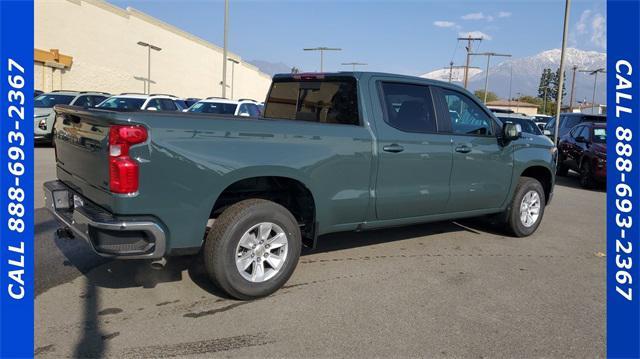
[203,199,302,300]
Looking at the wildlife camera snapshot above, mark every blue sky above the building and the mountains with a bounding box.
[105,0,606,75]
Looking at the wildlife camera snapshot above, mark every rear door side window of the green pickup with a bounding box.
[382,82,437,132]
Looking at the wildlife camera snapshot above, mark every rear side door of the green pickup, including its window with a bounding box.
[372,78,452,220]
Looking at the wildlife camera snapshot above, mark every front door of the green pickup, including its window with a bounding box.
[438,89,513,212]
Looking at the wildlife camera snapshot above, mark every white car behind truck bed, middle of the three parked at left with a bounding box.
[96,93,184,111]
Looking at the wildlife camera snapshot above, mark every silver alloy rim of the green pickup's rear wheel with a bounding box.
[236,222,289,283]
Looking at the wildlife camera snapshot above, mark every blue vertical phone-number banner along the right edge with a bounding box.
[607,0,640,358]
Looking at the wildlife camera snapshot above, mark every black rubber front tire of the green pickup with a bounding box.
[505,177,546,237]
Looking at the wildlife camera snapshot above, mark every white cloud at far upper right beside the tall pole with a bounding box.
[569,10,607,50]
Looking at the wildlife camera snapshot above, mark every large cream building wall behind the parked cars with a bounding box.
[34,0,271,100]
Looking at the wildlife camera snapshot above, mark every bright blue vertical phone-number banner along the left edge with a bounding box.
[0,1,34,358]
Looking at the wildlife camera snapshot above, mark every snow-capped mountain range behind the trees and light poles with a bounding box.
[422,48,606,103]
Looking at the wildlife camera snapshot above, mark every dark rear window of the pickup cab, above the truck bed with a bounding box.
[264,79,360,125]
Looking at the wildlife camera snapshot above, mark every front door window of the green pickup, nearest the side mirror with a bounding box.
[442,89,493,136]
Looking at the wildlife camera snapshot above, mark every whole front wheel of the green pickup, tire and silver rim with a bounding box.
[506,177,546,237]
